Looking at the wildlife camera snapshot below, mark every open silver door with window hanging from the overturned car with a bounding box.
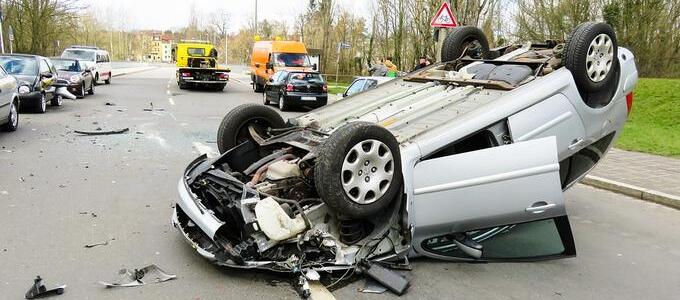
[412,137,576,261]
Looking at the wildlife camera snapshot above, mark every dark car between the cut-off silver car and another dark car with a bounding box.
[0,54,63,113]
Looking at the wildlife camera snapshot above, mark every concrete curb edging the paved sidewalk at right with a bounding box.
[581,175,680,209]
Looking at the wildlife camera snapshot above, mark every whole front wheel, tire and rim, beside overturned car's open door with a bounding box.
[314,122,402,218]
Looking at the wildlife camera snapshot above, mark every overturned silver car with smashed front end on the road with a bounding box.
[173,23,637,272]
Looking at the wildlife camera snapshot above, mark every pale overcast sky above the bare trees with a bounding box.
[82,0,371,31]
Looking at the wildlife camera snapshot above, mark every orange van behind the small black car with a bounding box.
[250,41,318,93]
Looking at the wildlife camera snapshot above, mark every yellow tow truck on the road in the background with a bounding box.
[174,40,231,91]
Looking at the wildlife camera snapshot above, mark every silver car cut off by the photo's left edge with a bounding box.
[0,67,19,131]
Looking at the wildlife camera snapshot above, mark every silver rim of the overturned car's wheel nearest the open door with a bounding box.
[340,140,394,204]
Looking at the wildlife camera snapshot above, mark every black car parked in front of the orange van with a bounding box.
[263,71,328,111]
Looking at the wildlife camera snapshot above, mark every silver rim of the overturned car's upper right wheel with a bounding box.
[586,33,614,82]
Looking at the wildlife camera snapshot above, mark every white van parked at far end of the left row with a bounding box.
[61,46,112,84]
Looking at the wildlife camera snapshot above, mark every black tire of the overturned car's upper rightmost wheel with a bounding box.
[564,22,619,94]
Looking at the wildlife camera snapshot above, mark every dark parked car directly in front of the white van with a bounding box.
[52,58,94,98]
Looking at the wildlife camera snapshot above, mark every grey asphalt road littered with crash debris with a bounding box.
[0,67,680,299]
